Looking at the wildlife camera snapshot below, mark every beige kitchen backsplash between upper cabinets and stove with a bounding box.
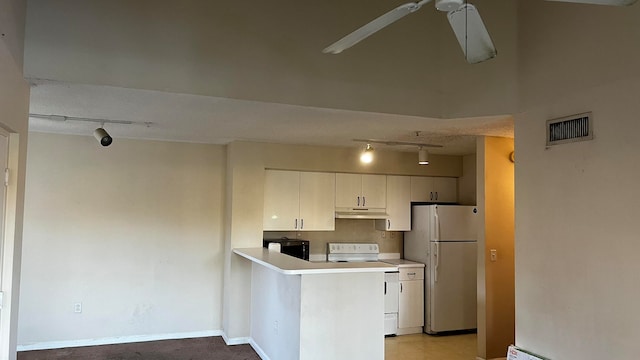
[264,219,403,256]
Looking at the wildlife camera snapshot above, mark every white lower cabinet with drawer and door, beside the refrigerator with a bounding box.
[398,267,424,335]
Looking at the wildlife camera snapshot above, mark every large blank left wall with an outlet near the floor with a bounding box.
[18,133,225,346]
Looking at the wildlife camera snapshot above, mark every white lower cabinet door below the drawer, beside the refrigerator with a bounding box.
[398,280,424,328]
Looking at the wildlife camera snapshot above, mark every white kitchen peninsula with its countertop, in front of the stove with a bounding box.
[233,248,394,360]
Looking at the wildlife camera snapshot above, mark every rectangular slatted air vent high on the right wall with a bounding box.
[547,112,593,146]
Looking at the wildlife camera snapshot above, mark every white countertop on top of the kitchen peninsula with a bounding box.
[233,247,397,275]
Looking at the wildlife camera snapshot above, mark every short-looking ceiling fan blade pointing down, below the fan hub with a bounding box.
[447,4,498,64]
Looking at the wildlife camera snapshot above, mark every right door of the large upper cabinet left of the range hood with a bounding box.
[299,172,336,231]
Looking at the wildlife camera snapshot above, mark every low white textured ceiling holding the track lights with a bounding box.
[29,79,513,155]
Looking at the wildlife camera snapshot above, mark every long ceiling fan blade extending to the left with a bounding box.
[322,0,431,54]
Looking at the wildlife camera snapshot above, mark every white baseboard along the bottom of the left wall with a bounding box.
[17,330,223,351]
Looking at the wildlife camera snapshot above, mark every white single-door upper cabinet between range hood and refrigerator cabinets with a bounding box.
[376,175,411,231]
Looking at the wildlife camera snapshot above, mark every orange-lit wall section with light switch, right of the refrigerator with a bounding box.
[478,137,515,359]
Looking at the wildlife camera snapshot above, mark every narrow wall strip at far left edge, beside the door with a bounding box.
[0,0,29,360]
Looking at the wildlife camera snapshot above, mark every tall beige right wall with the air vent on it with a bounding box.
[515,1,640,359]
